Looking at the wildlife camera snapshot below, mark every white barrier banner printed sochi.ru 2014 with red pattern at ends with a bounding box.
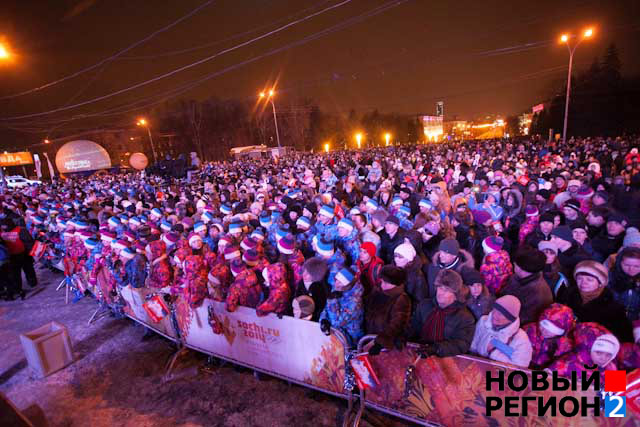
[180,300,344,393]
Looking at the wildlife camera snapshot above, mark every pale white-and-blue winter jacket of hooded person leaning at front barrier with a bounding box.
[471,313,533,368]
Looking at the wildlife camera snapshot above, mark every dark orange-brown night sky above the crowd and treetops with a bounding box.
[0,0,640,145]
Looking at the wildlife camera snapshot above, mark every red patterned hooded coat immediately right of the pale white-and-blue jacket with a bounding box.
[522,303,576,369]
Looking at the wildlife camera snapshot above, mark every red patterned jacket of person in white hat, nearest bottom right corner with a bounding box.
[549,322,616,378]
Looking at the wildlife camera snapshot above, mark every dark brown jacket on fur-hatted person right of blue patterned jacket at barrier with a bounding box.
[364,285,411,350]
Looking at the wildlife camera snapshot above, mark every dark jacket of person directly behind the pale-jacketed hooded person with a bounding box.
[499,273,553,325]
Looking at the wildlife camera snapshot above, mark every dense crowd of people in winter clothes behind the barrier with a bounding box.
[1,138,640,375]
